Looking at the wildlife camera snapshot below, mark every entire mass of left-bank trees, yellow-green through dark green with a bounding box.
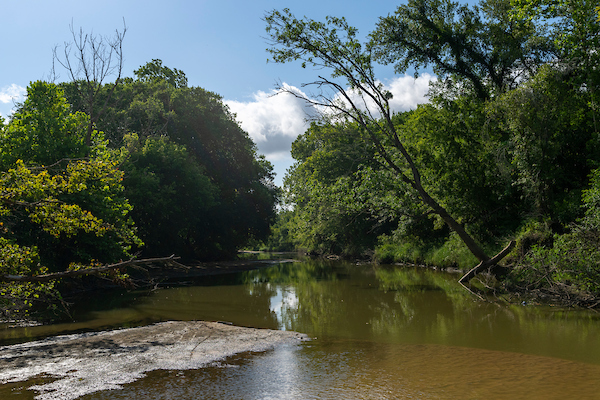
[0,60,279,317]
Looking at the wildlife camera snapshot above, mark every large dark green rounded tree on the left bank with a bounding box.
[63,60,278,260]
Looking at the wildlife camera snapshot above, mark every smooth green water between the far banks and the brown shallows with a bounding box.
[0,261,600,364]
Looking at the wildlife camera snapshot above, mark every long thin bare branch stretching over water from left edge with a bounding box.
[0,255,187,282]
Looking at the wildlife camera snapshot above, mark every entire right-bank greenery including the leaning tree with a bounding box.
[265,0,600,304]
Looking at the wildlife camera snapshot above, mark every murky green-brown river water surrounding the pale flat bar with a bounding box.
[0,261,600,399]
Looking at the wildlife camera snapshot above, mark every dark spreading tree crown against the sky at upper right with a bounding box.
[370,0,552,99]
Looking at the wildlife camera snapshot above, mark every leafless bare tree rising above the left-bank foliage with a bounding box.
[51,20,127,146]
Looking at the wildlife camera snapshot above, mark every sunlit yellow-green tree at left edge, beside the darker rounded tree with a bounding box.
[0,82,141,318]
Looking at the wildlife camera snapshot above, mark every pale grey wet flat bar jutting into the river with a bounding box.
[0,321,307,400]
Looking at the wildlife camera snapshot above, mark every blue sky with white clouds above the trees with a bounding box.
[0,0,434,185]
